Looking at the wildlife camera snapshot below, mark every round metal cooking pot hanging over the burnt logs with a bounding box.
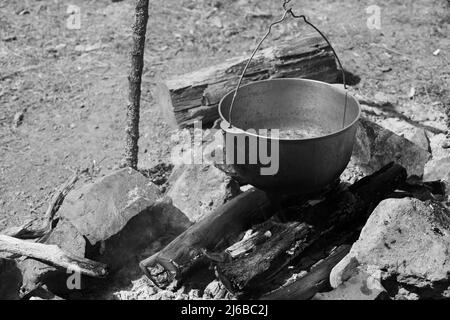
[219,79,361,194]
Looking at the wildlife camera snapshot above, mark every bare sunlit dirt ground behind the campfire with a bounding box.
[0,0,450,230]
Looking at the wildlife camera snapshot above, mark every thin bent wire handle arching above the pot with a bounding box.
[228,0,347,128]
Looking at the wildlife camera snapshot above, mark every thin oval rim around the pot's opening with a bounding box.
[218,78,361,141]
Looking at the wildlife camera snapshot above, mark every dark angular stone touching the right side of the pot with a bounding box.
[351,118,430,177]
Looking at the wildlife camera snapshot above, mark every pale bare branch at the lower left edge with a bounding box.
[0,235,108,278]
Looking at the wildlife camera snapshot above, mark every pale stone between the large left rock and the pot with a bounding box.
[167,164,240,222]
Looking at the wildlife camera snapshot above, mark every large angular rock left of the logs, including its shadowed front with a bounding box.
[59,168,191,274]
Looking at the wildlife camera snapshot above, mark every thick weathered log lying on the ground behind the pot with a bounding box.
[155,35,338,127]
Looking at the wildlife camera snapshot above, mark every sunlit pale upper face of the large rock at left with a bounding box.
[58,168,160,245]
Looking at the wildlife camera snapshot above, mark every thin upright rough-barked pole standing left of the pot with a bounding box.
[124,0,148,169]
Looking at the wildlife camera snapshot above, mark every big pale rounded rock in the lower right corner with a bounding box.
[330,198,450,297]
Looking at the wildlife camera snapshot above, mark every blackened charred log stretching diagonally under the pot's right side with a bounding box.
[216,163,406,295]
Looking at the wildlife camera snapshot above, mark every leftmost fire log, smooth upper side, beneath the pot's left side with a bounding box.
[140,189,272,286]
